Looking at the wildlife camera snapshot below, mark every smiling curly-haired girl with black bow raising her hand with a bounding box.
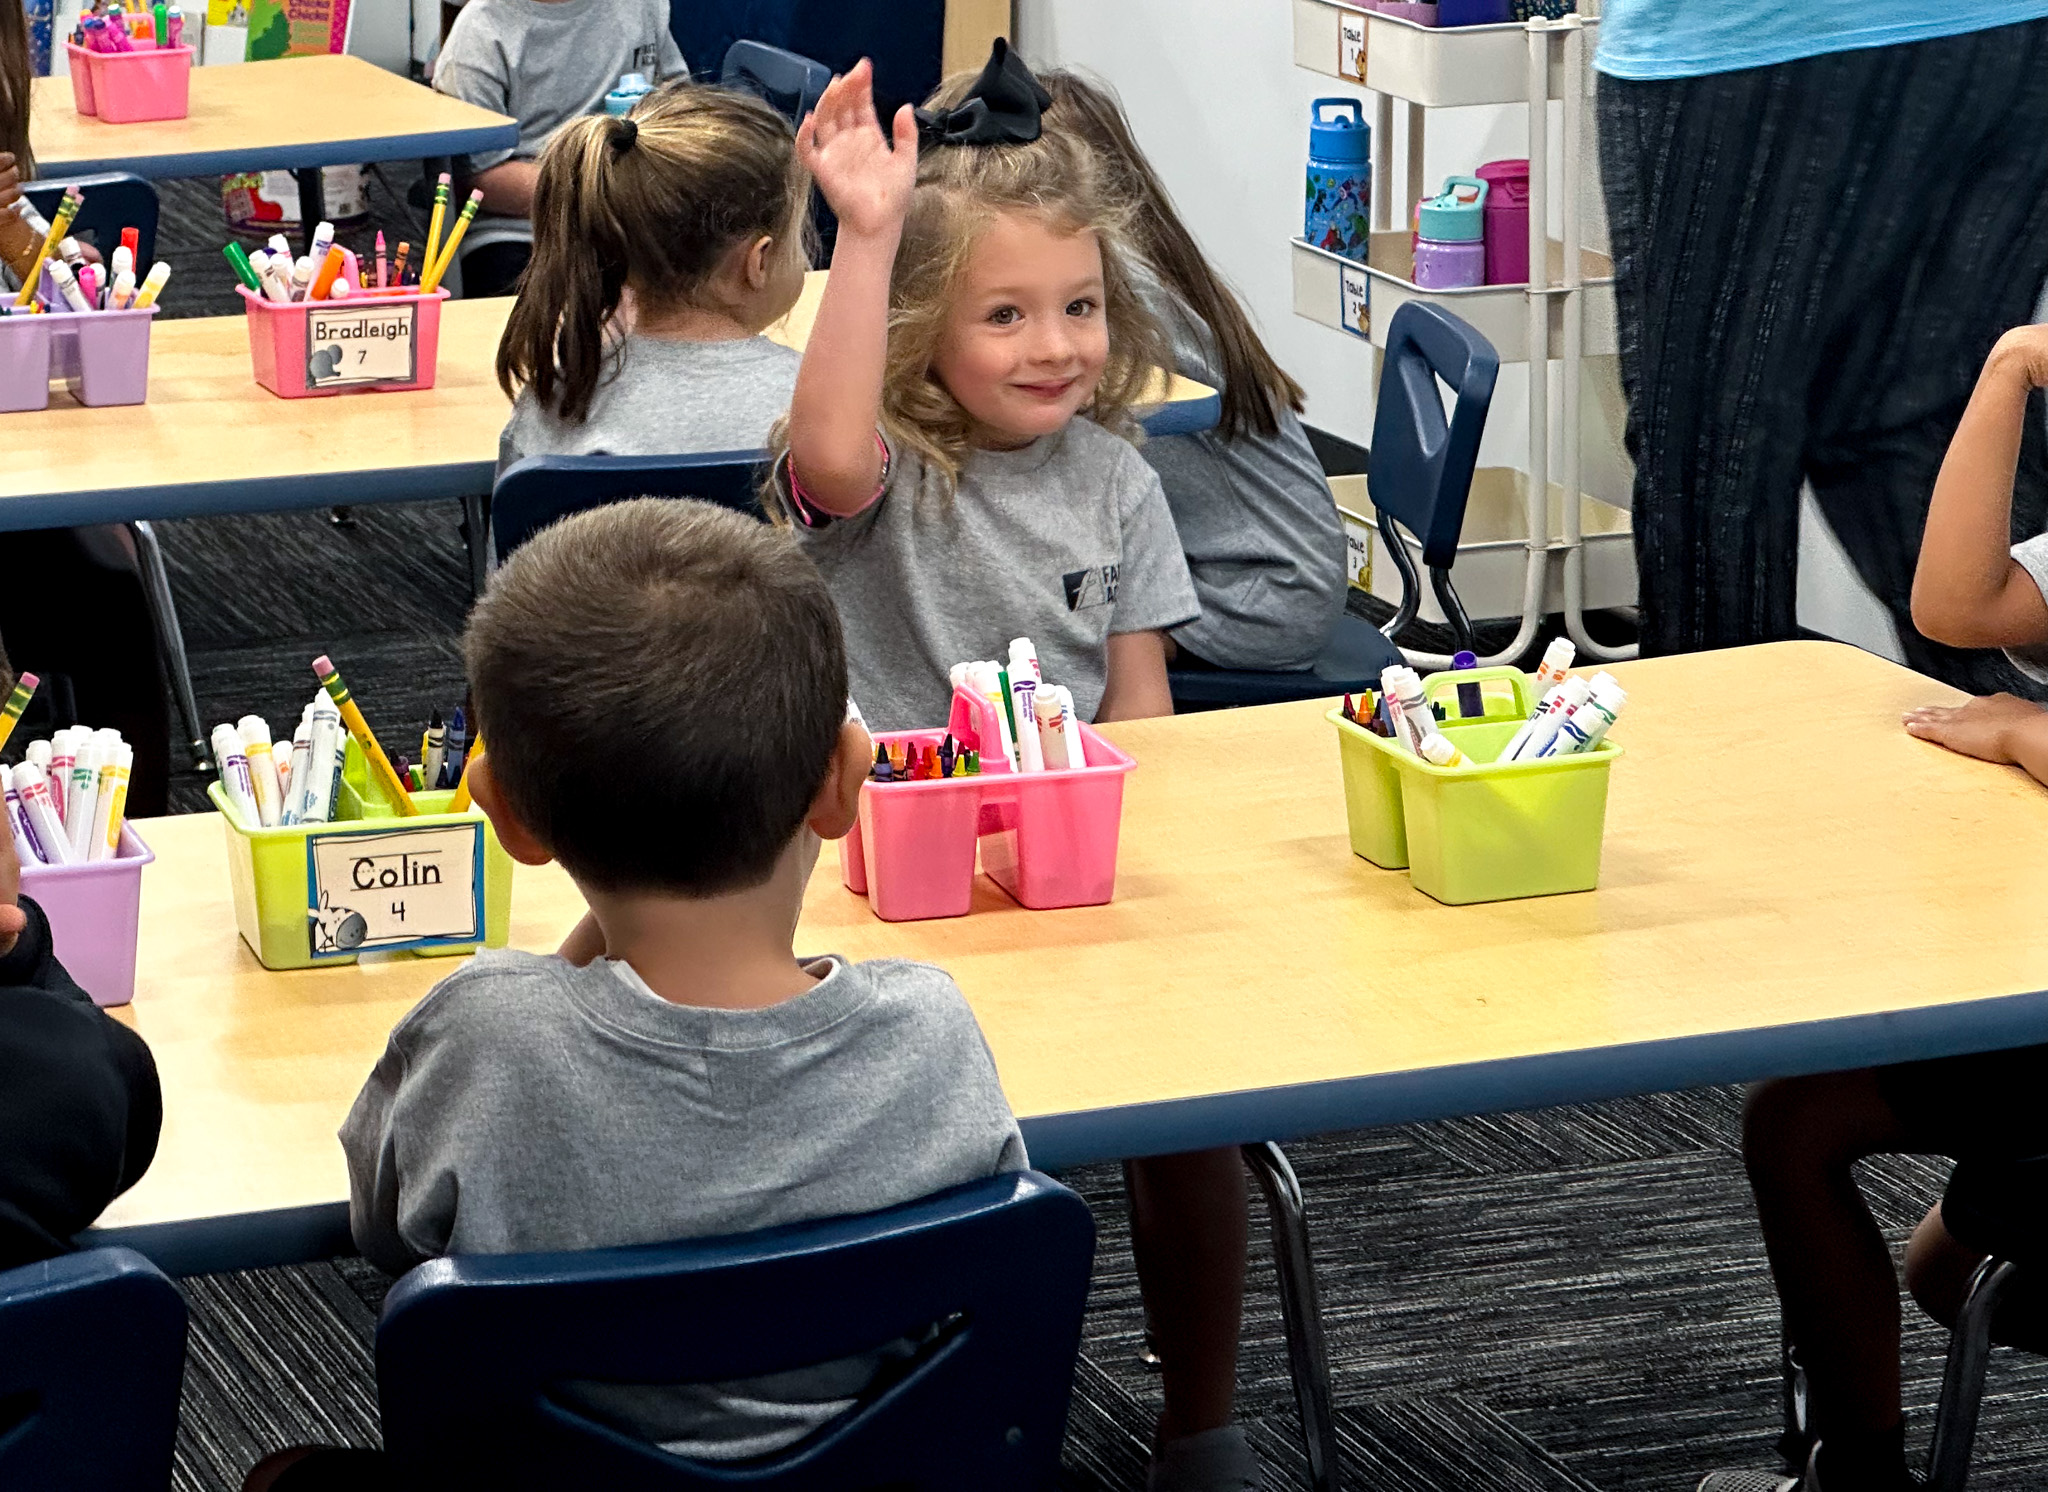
[770,55,1255,1492]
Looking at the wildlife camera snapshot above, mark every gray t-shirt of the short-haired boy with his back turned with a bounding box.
[342,950,1026,1459]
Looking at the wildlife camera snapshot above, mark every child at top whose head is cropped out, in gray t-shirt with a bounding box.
[434,0,690,295]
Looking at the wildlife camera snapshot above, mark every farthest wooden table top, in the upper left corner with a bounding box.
[29,57,518,180]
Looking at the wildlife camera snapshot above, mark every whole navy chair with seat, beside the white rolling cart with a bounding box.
[1167,301,1501,708]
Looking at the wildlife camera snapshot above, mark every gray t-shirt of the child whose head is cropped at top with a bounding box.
[434,0,690,174]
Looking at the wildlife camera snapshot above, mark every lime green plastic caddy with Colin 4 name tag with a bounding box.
[207,739,512,968]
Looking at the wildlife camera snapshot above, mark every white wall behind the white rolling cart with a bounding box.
[1007,0,1896,655]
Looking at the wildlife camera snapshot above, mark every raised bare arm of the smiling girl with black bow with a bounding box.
[788,57,918,518]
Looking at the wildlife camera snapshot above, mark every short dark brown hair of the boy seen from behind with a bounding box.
[463,497,846,896]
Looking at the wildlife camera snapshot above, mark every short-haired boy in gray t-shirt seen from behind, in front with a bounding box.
[252,497,1026,1488]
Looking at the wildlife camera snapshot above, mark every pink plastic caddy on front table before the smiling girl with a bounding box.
[840,690,1137,923]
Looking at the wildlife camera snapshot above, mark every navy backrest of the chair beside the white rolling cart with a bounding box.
[1366,301,1501,569]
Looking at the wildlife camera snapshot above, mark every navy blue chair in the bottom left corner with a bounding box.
[0,1248,184,1492]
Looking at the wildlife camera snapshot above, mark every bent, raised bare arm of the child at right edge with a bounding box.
[1913,325,2048,650]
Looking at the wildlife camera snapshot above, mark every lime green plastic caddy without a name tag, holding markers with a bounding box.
[1327,667,1622,907]
